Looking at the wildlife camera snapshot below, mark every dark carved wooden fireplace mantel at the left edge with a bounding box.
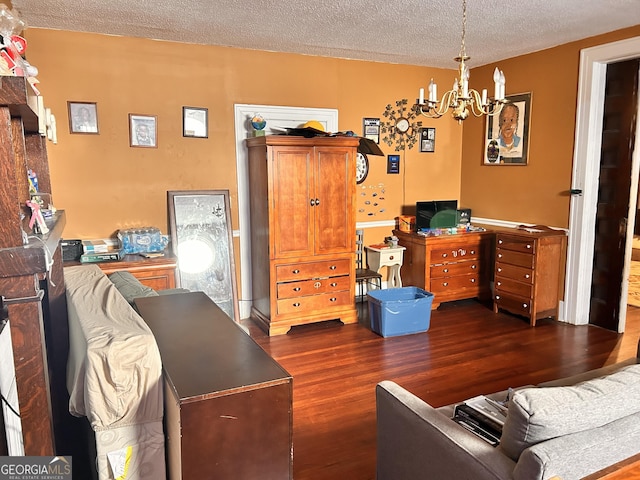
[0,76,70,456]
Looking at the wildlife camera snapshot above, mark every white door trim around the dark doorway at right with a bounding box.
[562,37,640,331]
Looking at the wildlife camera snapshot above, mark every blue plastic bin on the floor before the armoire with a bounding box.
[367,287,433,337]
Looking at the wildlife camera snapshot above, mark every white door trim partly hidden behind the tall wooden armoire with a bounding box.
[234,104,338,318]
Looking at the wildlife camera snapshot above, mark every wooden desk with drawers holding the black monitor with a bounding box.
[393,230,494,309]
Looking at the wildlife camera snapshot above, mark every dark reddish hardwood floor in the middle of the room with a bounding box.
[243,300,640,480]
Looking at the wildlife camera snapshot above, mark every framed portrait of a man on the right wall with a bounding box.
[483,93,531,165]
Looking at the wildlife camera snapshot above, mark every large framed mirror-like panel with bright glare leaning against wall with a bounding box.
[167,190,240,322]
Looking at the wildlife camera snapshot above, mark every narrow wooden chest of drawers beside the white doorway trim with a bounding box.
[493,225,567,326]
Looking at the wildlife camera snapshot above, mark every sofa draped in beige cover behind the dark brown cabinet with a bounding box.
[64,265,182,480]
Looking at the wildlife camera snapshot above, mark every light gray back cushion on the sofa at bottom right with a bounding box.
[500,365,640,461]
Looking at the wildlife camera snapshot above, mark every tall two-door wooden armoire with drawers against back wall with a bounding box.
[247,135,359,335]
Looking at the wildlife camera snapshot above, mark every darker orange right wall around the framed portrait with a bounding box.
[461,26,640,228]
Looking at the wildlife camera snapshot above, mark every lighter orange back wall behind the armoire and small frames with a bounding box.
[25,28,462,241]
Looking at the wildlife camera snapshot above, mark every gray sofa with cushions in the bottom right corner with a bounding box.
[376,342,640,480]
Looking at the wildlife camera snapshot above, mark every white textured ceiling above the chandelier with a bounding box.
[12,0,640,68]
